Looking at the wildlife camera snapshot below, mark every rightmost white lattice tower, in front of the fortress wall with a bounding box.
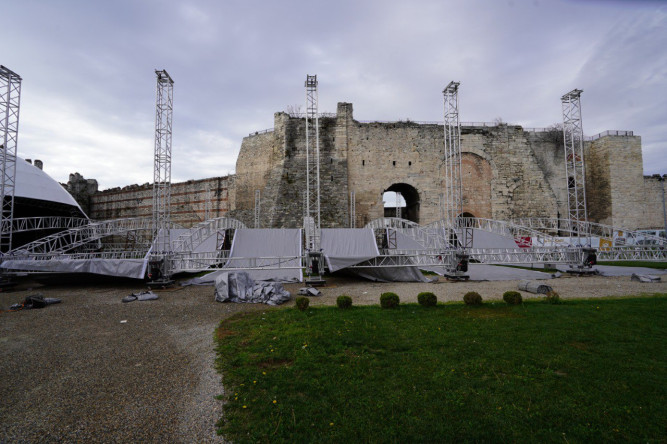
[561,89,588,236]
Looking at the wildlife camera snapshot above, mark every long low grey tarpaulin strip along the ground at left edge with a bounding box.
[0,259,148,279]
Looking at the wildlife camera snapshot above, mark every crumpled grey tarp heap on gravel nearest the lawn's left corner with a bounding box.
[215,271,291,305]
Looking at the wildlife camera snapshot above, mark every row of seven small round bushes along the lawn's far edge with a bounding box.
[296,290,560,311]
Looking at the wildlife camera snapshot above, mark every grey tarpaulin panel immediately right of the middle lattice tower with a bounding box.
[320,228,380,273]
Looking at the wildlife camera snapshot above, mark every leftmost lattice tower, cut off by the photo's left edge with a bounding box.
[0,65,21,253]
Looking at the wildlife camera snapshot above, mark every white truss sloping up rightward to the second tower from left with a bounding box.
[10,218,153,256]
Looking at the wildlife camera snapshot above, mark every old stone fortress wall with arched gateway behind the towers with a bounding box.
[68,103,664,229]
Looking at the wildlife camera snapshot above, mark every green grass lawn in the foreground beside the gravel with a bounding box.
[216,295,667,442]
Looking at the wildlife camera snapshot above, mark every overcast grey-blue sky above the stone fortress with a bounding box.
[0,0,667,189]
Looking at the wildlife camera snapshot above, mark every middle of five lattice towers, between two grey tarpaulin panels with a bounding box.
[305,75,321,250]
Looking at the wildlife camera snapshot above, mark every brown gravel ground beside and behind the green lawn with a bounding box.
[0,270,667,443]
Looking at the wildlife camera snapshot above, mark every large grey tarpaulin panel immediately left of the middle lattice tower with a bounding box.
[224,228,303,282]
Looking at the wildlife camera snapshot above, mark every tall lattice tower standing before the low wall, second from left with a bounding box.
[153,69,174,279]
